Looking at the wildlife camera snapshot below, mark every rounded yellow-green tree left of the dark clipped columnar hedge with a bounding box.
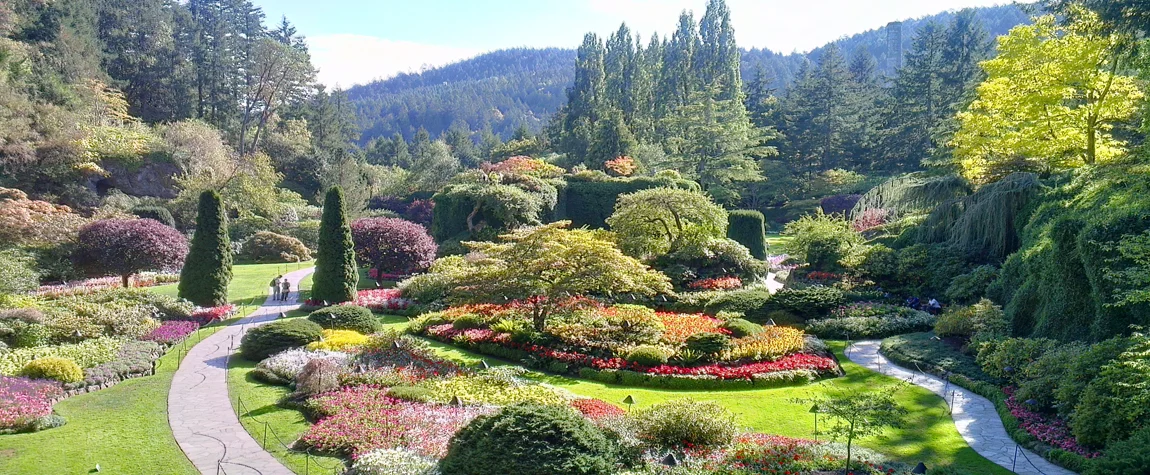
[607,187,727,258]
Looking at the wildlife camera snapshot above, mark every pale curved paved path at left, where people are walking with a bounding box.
[168,268,314,475]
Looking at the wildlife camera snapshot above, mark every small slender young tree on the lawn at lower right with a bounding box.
[795,386,906,470]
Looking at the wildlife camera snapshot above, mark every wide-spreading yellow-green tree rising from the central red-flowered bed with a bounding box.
[452,221,670,331]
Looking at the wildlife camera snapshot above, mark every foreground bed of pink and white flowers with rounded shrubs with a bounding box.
[244,326,910,474]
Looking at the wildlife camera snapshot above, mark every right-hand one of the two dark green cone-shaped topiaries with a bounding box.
[312,186,359,304]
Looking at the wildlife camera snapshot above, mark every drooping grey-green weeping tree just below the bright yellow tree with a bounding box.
[918,173,1043,261]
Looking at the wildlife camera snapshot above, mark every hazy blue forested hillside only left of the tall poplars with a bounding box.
[347,48,575,143]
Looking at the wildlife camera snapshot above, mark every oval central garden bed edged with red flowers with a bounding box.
[412,298,841,389]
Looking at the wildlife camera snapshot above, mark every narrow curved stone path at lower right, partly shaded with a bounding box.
[846,340,1074,475]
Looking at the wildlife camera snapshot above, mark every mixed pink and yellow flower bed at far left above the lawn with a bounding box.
[0,289,236,434]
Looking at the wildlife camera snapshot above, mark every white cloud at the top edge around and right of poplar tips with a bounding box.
[588,0,1009,53]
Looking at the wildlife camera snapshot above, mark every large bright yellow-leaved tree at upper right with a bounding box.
[953,9,1143,183]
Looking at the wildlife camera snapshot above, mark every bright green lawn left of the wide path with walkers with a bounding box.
[0,265,306,475]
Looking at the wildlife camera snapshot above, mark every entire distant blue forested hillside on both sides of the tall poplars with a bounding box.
[348,5,1029,143]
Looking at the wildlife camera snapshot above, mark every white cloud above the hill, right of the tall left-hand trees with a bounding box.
[307,35,482,87]
